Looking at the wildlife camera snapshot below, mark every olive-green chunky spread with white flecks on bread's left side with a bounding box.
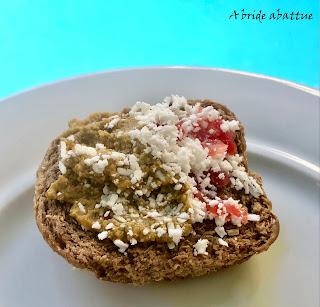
[47,113,192,244]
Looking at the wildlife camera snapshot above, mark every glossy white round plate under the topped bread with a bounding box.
[0,67,320,307]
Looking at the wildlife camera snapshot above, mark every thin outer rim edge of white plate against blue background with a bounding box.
[0,65,320,104]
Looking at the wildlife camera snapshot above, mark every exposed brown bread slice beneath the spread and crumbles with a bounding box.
[34,100,279,284]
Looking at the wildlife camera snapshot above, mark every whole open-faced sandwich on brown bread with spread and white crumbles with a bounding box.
[35,96,279,284]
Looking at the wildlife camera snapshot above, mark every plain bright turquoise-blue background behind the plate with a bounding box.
[0,0,320,97]
